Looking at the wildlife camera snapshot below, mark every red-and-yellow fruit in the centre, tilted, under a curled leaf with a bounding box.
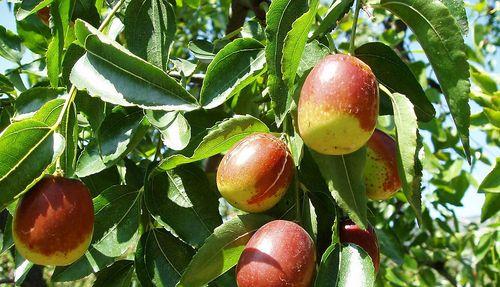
[217,133,295,212]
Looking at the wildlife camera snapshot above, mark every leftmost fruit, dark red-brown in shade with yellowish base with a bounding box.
[12,176,94,266]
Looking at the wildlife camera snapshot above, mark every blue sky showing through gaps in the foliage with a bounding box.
[0,1,500,219]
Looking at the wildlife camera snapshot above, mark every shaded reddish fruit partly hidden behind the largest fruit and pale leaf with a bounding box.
[364,130,401,200]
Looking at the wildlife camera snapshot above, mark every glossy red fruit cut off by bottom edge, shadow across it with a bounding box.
[236,220,316,287]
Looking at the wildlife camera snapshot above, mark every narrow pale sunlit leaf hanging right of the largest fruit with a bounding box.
[389,93,422,222]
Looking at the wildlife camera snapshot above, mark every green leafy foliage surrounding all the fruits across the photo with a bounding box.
[0,0,500,287]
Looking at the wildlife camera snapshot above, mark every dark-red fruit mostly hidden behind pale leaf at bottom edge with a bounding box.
[339,220,380,274]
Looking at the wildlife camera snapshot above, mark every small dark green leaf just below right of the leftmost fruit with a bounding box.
[50,250,115,282]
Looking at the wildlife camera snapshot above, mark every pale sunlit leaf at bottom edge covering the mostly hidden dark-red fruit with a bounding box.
[336,244,375,287]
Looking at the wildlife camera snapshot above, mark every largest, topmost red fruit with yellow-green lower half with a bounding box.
[297,54,379,155]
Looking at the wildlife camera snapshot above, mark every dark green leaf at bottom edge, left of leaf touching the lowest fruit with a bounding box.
[135,229,194,287]
